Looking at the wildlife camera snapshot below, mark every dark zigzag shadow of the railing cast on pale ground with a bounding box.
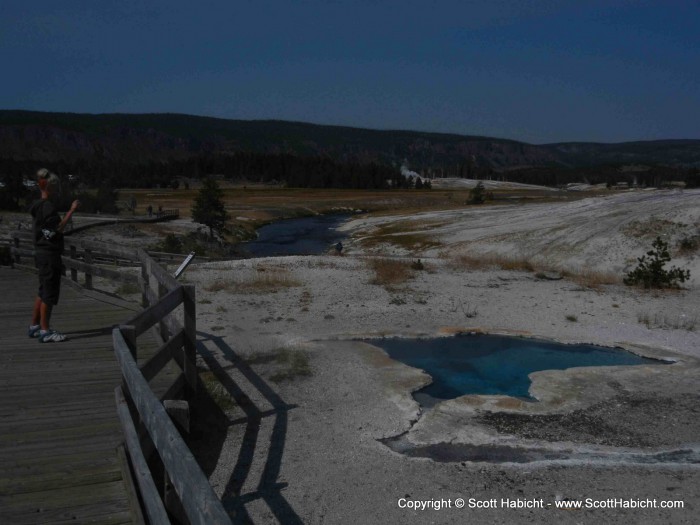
[197,332,302,524]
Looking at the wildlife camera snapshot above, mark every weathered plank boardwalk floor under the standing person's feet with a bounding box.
[0,267,139,524]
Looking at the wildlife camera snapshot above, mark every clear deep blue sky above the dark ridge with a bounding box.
[0,0,700,143]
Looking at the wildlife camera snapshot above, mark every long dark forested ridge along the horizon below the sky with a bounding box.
[0,110,700,168]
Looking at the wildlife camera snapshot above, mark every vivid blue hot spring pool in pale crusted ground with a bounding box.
[367,334,663,406]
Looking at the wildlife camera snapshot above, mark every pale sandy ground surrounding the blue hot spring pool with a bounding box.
[174,191,700,524]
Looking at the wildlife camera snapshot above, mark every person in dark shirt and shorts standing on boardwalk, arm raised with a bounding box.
[28,168,80,343]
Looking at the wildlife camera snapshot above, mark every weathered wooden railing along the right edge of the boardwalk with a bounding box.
[8,231,231,525]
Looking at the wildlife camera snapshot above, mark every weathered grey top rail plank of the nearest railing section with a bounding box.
[112,328,231,525]
